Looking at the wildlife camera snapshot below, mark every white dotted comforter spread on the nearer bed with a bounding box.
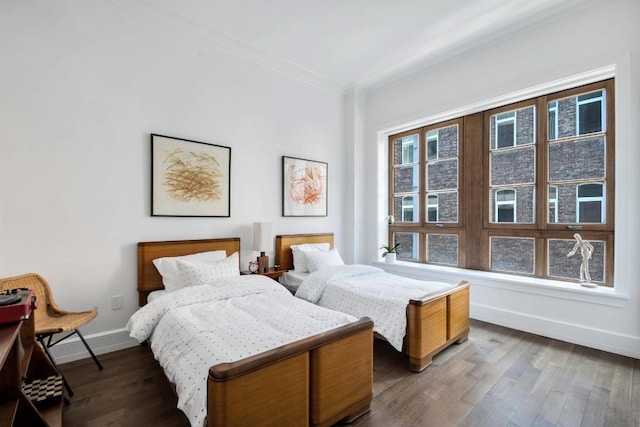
[127,276,357,426]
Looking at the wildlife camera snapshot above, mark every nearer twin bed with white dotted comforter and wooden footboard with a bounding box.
[127,238,373,426]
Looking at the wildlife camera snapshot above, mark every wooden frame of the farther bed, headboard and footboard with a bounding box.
[275,233,469,372]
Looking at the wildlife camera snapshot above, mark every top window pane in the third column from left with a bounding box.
[491,106,536,149]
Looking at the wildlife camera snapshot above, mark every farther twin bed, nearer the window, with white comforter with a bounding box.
[275,233,469,372]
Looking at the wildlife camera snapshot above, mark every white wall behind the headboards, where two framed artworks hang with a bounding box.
[0,0,345,361]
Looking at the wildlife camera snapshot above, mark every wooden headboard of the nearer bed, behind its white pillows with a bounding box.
[138,237,240,307]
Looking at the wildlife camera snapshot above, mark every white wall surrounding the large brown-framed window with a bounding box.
[359,0,640,357]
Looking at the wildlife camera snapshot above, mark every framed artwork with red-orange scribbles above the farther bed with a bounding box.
[282,156,328,216]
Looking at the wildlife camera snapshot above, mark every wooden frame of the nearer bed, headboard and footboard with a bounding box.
[138,238,373,426]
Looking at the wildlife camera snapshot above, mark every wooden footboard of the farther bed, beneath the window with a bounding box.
[405,281,469,372]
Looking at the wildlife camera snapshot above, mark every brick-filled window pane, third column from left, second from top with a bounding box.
[491,146,536,185]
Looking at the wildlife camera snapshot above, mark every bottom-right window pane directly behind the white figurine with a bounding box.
[547,239,606,283]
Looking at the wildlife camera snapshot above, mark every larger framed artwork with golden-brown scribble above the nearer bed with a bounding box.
[151,134,231,217]
